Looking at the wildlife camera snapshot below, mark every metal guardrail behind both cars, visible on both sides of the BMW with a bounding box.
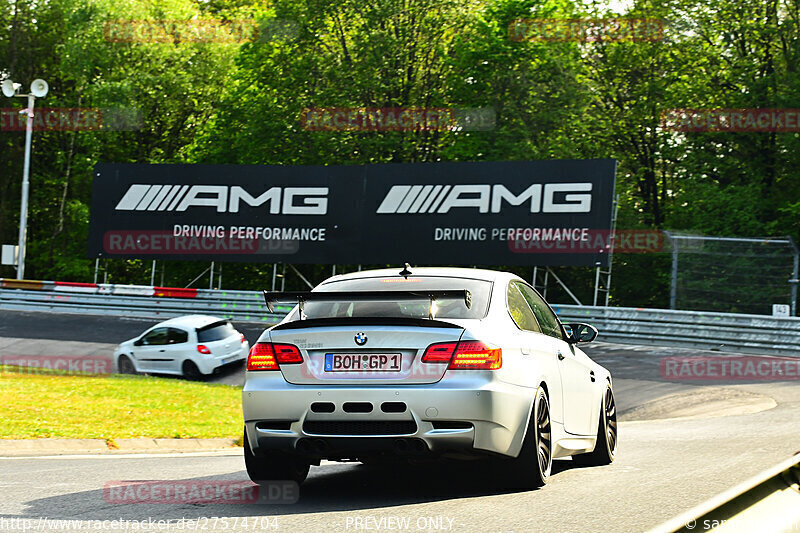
[0,282,800,356]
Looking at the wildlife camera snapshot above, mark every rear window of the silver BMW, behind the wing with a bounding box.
[292,276,492,320]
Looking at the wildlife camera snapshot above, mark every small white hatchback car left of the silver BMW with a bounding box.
[114,315,250,379]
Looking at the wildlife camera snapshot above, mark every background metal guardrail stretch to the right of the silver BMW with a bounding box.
[553,305,800,356]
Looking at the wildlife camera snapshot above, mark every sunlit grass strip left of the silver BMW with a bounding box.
[0,366,243,441]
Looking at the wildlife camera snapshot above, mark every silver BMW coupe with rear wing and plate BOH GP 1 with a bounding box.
[242,265,617,487]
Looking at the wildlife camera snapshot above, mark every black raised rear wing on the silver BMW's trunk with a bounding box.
[264,289,472,319]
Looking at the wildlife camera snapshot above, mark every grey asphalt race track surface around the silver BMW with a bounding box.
[0,311,800,532]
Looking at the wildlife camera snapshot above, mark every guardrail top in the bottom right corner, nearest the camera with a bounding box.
[649,455,800,533]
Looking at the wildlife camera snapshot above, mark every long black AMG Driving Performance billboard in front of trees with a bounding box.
[89,159,616,266]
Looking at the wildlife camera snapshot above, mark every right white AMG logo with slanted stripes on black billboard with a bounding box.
[376,182,592,214]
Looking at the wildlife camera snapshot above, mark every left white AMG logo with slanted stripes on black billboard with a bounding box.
[116,184,328,215]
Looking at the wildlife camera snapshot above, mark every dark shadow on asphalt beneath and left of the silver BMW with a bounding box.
[14,460,588,520]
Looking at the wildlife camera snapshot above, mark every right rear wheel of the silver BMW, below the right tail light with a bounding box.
[507,387,553,489]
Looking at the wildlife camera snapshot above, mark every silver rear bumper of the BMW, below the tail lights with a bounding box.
[242,371,534,458]
